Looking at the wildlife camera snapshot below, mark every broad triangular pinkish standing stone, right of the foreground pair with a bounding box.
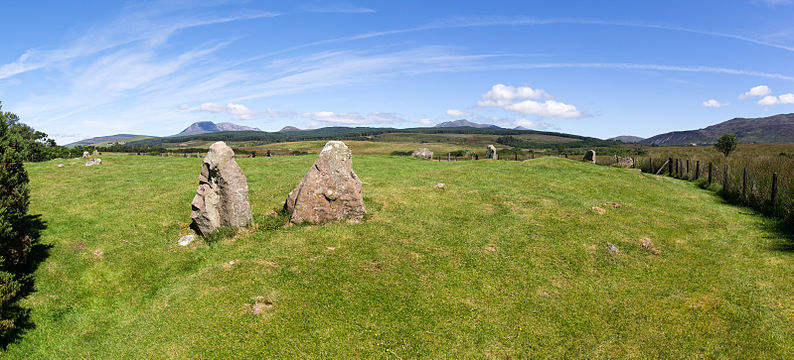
[284,141,366,223]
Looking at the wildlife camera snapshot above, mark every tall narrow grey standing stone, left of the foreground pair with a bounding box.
[190,141,252,235]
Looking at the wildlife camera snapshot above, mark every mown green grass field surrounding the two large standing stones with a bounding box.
[3,153,794,359]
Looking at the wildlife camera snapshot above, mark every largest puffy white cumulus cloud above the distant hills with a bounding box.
[477,84,582,118]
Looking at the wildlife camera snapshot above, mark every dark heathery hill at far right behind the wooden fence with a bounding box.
[640,113,794,146]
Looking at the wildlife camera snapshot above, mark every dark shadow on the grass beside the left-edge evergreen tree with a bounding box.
[0,215,52,349]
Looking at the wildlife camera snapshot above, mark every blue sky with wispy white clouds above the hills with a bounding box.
[0,0,794,143]
